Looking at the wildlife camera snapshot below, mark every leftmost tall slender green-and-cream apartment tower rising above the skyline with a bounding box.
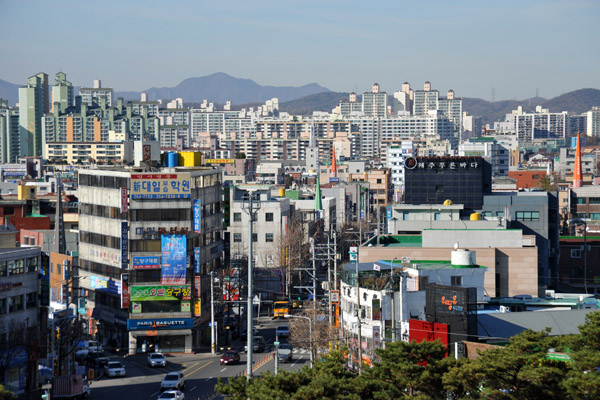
[19,72,49,157]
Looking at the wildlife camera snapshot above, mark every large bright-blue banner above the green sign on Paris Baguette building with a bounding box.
[160,235,187,285]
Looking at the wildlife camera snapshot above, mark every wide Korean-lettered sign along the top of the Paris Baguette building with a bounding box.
[130,173,192,200]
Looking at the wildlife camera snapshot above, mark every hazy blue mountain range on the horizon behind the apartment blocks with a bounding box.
[0,72,600,123]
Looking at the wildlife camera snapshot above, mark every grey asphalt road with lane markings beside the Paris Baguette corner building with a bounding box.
[91,318,310,400]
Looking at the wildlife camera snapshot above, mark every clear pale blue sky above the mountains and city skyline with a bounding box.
[0,0,600,100]
